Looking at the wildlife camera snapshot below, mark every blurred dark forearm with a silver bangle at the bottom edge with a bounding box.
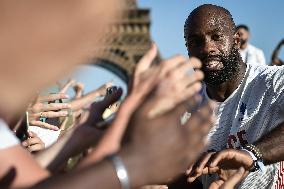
[30,152,146,189]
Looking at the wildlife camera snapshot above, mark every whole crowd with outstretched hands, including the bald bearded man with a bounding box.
[0,0,284,189]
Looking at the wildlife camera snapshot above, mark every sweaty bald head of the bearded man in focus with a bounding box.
[184,4,241,86]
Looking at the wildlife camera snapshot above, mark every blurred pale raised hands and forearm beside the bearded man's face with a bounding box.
[79,45,206,165]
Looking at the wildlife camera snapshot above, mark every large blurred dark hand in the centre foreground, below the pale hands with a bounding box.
[114,91,214,188]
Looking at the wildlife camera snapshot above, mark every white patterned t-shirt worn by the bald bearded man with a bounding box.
[202,65,284,189]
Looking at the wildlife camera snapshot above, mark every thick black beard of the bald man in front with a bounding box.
[201,45,240,86]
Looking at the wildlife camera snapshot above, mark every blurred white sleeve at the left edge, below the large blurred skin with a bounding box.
[0,119,20,150]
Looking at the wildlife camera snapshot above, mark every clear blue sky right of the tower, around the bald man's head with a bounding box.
[137,0,284,62]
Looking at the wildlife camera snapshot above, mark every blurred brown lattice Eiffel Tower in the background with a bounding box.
[96,0,159,83]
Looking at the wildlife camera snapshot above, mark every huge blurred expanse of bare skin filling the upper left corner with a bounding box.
[0,0,122,120]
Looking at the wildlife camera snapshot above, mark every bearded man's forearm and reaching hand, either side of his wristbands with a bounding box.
[187,123,284,185]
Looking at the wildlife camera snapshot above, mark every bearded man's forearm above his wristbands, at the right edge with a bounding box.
[255,123,284,164]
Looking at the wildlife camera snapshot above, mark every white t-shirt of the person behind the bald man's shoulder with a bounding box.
[240,44,266,65]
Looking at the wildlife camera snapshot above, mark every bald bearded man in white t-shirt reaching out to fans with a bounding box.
[184,4,284,189]
